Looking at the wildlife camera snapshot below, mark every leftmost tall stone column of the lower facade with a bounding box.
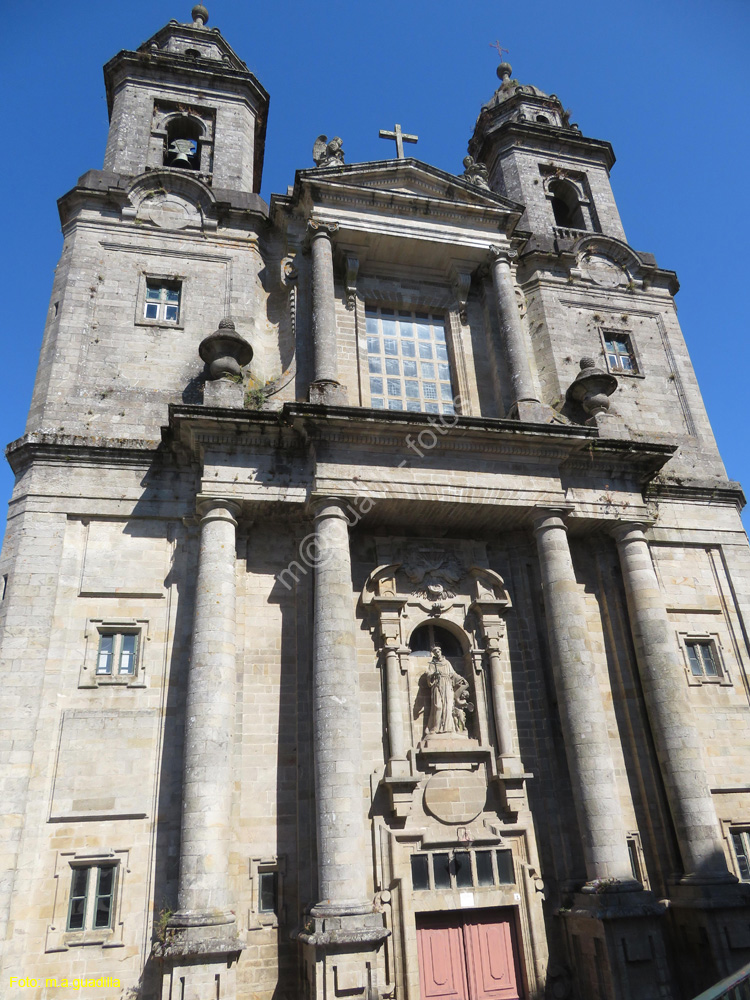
[170,498,239,950]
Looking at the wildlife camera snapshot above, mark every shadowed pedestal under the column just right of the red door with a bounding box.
[560,882,674,1000]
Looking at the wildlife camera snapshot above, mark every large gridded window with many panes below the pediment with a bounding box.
[366,308,454,413]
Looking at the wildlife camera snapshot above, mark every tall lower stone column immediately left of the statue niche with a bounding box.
[313,498,372,915]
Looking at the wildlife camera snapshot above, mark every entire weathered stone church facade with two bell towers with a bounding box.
[0,5,750,1000]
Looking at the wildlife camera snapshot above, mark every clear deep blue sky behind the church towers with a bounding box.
[0,0,750,540]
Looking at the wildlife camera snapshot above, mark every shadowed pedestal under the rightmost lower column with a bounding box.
[669,876,750,996]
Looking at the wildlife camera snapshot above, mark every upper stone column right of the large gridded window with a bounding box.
[490,246,543,421]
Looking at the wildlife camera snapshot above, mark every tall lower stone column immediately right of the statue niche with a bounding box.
[534,510,640,888]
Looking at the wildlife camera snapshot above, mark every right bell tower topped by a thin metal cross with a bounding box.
[476,62,625,240]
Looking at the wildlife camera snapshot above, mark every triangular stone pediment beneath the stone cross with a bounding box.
[294,158,523,218]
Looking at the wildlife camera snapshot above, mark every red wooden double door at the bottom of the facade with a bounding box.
[417,910,522,1000]
